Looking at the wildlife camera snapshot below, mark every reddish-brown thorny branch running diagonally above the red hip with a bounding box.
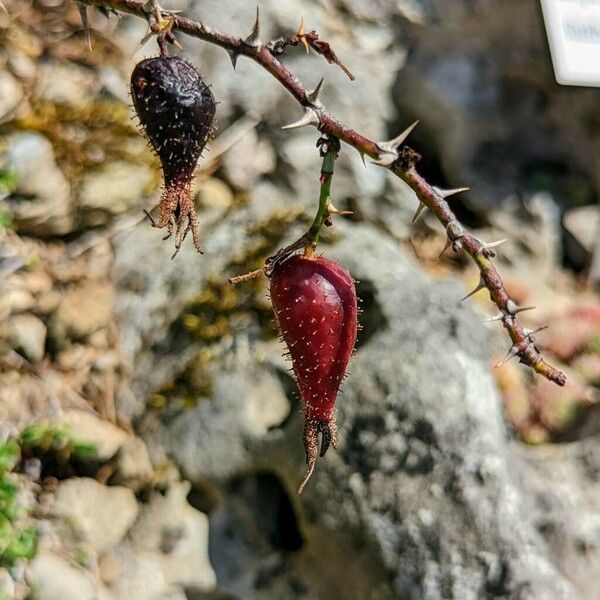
[79,0,566,386]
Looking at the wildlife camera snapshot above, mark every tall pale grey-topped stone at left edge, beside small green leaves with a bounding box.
[5,133,73,237]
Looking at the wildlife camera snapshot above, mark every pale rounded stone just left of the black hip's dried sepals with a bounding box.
[79,162,153,227]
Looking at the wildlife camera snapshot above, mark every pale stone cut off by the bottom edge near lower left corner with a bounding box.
[27,551,114,600]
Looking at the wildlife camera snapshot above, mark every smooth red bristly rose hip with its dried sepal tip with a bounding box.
[271,255,358,494]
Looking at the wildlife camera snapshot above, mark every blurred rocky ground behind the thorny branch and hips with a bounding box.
[0,0,600,600]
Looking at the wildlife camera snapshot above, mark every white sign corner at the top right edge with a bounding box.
[541,0,600,87]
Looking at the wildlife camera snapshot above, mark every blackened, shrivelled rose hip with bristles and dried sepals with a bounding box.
[131,56,215,256]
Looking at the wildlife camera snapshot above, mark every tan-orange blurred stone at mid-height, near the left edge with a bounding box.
[51,282,113,340]
